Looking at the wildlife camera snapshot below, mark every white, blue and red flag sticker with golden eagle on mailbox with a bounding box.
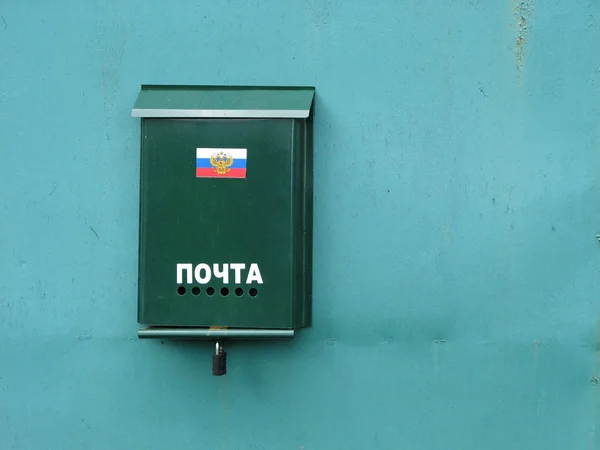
[196,148,247,178]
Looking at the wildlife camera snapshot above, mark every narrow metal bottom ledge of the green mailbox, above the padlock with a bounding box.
[138,327,295,338]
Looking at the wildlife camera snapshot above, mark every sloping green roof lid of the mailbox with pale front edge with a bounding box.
[131,85,315,119]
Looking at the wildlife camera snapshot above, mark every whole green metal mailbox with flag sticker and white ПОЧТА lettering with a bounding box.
[132,85,315,368]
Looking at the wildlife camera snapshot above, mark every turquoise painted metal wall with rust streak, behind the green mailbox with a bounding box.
[0,0,600,450]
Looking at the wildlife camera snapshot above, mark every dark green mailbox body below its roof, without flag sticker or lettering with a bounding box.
[139,112,312,328]
